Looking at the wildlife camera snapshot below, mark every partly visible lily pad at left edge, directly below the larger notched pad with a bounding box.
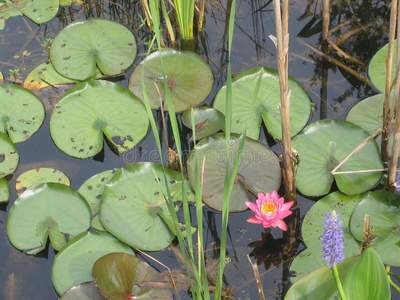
[0,131,19,178]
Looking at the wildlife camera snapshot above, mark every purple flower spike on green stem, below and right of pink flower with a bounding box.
[321,211,344,268]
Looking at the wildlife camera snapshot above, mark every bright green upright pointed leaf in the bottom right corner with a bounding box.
[338,248,392,300]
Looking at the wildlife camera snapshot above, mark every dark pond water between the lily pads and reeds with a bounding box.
[0,0,389,300]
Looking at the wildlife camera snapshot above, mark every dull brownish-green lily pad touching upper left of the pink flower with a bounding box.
[187,133,281,212]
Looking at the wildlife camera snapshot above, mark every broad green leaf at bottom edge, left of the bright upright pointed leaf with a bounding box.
[285,256,358,300]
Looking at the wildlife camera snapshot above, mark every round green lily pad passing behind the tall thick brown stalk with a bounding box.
[213,68,311,140]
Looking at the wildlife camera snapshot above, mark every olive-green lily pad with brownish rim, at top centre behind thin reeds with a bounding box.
[129,49,214,112]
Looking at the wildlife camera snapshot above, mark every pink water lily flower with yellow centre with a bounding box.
[246,191,294,231]
